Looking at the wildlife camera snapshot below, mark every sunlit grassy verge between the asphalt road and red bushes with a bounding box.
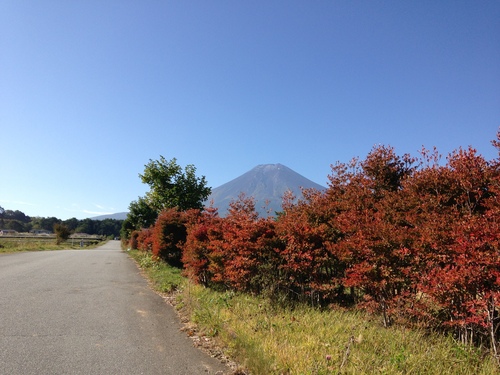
[127,252,500,375]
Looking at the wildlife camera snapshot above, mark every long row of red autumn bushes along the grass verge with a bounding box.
[182,133,500,351]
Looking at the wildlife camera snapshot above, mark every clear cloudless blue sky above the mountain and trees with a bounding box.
[0,0,500,219]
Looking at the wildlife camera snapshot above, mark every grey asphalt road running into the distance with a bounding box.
[0,241,230,375]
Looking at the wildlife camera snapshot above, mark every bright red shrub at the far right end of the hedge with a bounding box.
[409,148,500,342]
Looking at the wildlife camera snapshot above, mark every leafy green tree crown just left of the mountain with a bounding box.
[139,156,211,213]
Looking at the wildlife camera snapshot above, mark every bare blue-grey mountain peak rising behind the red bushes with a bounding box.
[207,164,325,217]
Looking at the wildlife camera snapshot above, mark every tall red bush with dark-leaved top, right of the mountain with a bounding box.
[325,146,422,326]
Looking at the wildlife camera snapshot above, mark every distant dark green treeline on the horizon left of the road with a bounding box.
[0,207,123,237]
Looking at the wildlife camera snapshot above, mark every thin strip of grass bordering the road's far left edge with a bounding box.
[0,237,104,253]
